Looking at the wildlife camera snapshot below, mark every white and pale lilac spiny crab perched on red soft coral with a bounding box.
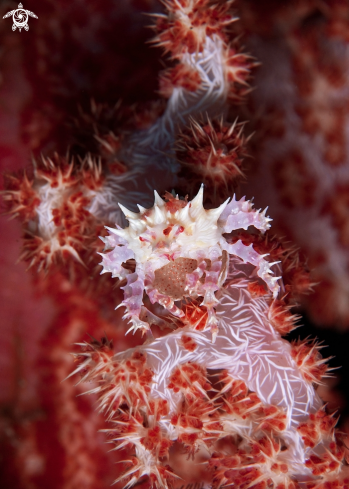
[102,185,279,339]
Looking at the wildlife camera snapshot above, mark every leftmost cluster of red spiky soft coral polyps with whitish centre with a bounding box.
[5,155,103,270]
